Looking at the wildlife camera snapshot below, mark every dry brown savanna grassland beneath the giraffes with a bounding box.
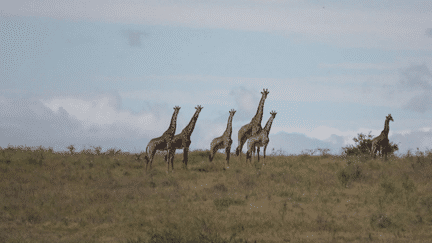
[0,147,432,243]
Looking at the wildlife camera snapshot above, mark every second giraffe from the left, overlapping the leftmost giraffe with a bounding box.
[169,105,203,170]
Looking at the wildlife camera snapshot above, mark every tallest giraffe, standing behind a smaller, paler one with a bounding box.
[236,89,269,156]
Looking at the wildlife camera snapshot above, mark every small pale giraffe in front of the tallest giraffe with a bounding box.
[246,111,277,166]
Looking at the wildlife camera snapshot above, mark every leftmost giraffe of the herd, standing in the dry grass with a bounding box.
[144,106,180,170]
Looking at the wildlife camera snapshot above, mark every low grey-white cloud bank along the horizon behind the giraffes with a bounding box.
[0,92,432,153]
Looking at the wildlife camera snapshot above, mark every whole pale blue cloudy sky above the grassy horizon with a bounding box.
[0,0,432,154]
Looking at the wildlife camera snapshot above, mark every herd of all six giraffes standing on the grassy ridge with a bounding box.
[144,89,393,172]
